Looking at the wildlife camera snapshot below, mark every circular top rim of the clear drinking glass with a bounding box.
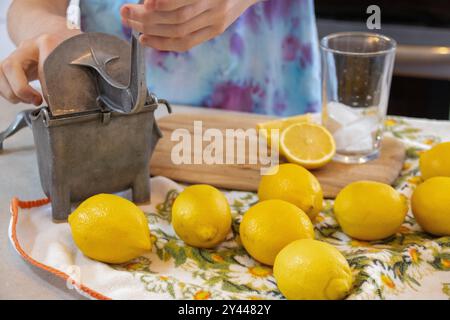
[320,31,397,57]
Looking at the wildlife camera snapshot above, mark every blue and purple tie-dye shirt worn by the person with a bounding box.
[81,0,320,116]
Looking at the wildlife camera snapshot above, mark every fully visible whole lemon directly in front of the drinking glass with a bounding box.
[334,181,408,241]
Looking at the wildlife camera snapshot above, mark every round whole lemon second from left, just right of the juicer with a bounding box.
[172,184,231,248]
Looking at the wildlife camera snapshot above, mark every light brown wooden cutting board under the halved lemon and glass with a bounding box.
[150,112,405,198]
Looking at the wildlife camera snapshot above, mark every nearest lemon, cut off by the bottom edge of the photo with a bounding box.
[273,239,353,300]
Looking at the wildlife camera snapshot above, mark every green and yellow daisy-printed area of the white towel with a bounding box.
[106,118,450,299]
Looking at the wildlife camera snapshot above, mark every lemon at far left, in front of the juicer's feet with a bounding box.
[69,194,152,263]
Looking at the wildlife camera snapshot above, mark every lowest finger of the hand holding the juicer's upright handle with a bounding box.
[139,27,217,52]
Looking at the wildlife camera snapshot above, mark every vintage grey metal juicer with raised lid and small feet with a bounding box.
[0,33,171,220]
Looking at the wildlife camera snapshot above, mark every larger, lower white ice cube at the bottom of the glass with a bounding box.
[333,117,379,152]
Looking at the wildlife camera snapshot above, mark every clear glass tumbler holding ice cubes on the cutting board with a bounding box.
[320,32,396,163]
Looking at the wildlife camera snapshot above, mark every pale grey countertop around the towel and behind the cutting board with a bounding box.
[0,98,220,299]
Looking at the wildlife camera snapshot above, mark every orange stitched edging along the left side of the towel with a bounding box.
[11,198,111,300]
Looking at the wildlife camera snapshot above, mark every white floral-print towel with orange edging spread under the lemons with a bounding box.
[10,115,450,300]
